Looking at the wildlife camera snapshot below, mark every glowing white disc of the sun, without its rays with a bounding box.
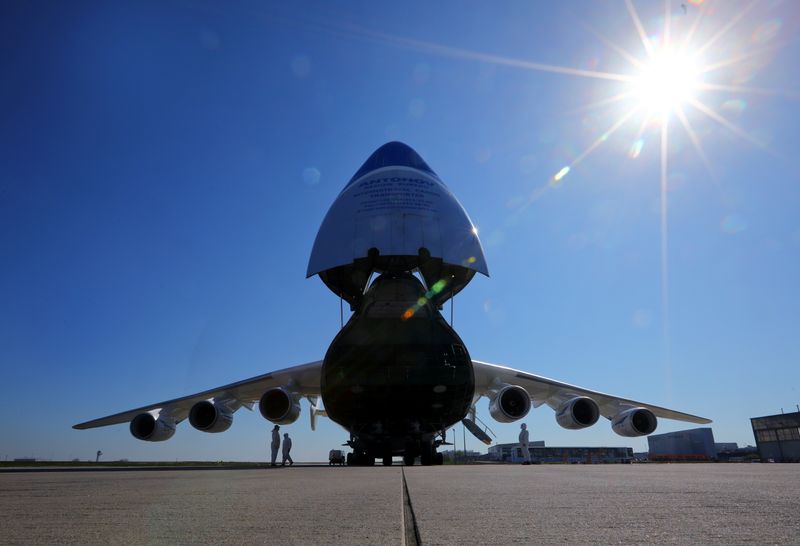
[632,47,700,115]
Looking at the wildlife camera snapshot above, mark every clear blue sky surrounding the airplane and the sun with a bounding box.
[0,0,800,460]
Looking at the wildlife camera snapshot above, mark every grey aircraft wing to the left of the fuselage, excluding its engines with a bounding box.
[72,360,322,430]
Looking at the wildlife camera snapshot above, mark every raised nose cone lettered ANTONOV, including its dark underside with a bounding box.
[306,142,489,303]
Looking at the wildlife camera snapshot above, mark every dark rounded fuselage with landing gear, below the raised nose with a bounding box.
[322,272,475,458]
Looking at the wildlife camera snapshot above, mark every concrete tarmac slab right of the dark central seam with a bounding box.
[406,464,800,544]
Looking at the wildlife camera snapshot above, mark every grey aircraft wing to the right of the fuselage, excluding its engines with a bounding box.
[472,360,711,424]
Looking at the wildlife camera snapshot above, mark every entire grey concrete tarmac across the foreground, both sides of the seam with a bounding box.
[0,464,800,545]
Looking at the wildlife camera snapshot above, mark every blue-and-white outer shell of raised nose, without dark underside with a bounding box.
[306,142,489,278]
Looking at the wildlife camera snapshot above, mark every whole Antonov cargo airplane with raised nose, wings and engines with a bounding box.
[74,142,710,465]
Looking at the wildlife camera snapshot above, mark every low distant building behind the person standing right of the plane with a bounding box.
[489,441,633,464]
